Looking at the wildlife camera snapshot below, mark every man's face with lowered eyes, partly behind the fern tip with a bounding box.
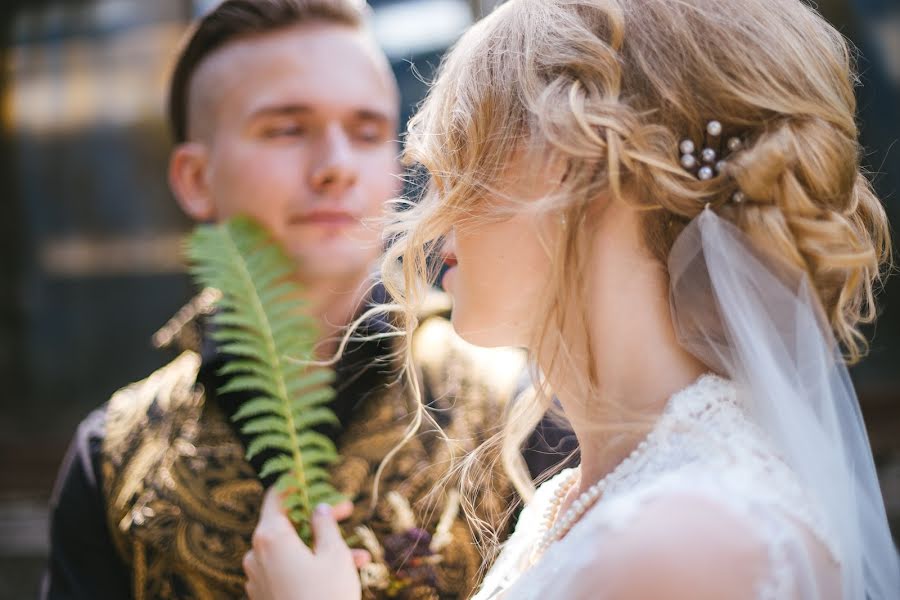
[182,24,400,279]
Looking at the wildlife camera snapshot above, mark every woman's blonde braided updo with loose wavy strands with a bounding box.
[385,0,890,564]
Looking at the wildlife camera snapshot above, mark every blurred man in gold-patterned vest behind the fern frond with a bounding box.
[38,0,544,600]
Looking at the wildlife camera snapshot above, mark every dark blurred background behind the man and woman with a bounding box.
[0,0,900,599]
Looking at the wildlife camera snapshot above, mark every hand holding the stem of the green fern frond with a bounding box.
[244,489,370,600]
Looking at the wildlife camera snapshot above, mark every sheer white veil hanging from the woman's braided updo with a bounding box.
[669,207,900,600]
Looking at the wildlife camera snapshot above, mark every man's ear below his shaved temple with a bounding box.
[169,142,216,223]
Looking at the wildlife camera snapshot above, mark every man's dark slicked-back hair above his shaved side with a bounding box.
[168,0,365,143]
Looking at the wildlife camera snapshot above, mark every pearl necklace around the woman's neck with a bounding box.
[532,431,653,562]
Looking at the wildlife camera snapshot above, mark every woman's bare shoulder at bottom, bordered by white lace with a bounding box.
[573,490,838,600]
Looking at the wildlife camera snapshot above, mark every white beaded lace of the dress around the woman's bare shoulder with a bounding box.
[474,375,835,600]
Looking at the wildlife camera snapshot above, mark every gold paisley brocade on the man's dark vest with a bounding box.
[102,317,524,600]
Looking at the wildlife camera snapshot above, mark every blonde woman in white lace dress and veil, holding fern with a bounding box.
[245,0,900,600]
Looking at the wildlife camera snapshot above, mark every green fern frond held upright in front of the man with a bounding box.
[187,218,343,542]
